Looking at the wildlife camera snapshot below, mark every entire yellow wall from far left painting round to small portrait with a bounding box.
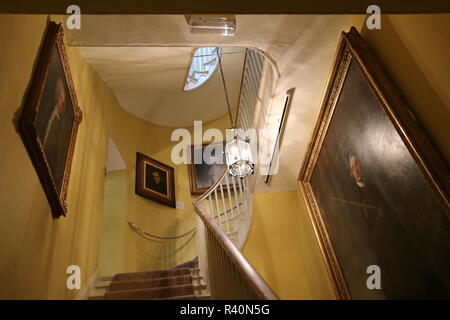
[0,15,232,299]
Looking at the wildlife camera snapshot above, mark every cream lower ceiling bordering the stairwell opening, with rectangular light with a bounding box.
[66,15,352,192]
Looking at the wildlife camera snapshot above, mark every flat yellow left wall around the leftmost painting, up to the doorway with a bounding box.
[0,15,112,299]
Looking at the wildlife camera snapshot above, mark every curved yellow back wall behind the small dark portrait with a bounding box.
[108,108,228,272]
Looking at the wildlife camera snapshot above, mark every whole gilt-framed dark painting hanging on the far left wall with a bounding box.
[19,22,82,218]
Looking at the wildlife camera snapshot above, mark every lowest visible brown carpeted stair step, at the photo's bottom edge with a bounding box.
[105,284,195,300]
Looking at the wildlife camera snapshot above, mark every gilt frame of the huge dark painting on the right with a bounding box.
[298,27,450,299]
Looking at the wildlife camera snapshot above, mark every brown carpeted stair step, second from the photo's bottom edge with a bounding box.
[108,275,192,291]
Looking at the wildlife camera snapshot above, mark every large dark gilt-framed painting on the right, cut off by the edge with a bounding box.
[299,28,450,299]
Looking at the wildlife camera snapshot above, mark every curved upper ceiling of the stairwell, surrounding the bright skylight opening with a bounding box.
[79,47,245,127]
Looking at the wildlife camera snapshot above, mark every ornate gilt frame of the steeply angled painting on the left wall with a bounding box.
[19,22,83,218]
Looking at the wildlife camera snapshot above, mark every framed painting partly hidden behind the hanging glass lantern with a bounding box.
[188,142,227,195]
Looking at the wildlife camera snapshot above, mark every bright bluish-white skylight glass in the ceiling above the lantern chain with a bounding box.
[184,47,220,91]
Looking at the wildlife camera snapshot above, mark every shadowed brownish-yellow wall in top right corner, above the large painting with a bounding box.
[360,15,450,161]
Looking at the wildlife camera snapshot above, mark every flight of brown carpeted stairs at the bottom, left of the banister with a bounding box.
[88,258,210,300]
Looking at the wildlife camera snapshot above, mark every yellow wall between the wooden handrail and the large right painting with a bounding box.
[243,191,334,299]
